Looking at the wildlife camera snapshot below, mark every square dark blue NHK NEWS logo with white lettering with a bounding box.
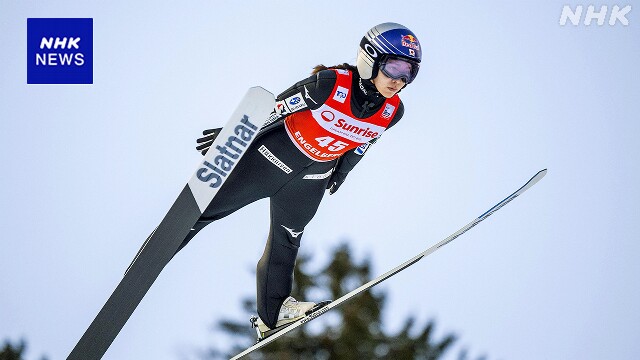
[27,18,93,84]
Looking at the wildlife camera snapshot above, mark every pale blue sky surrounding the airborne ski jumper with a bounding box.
[0,0,640,360]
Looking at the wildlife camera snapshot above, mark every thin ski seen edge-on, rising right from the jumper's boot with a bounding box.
[231,169,547,360]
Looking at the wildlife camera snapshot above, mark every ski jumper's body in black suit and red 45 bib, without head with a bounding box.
[180,69,404,328]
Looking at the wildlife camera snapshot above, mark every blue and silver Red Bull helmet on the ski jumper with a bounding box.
[356,23,422,84]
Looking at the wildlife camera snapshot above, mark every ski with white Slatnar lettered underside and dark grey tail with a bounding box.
[67,87,275,360]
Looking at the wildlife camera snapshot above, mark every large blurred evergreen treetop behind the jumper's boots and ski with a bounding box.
[207,244,456,360]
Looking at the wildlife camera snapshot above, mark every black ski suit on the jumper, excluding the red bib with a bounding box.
[180,70,404,328]
